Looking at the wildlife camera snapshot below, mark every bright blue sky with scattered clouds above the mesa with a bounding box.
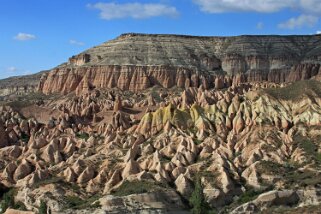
[0,0,321,79]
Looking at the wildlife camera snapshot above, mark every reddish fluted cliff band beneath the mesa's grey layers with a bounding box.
[38,64,321,94]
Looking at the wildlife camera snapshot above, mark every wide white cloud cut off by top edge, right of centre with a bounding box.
[194,0,297,13]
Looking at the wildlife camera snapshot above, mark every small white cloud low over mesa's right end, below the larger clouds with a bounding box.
[278,15,319,30]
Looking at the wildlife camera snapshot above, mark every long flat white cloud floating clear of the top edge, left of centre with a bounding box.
[88,3,179,20]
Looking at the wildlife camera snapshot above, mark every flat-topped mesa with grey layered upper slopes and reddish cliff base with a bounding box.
[38,34,321,94]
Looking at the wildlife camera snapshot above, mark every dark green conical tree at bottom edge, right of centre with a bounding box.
[189,176,210,214]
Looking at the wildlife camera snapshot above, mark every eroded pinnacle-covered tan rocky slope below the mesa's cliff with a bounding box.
[0,80,321,213]
